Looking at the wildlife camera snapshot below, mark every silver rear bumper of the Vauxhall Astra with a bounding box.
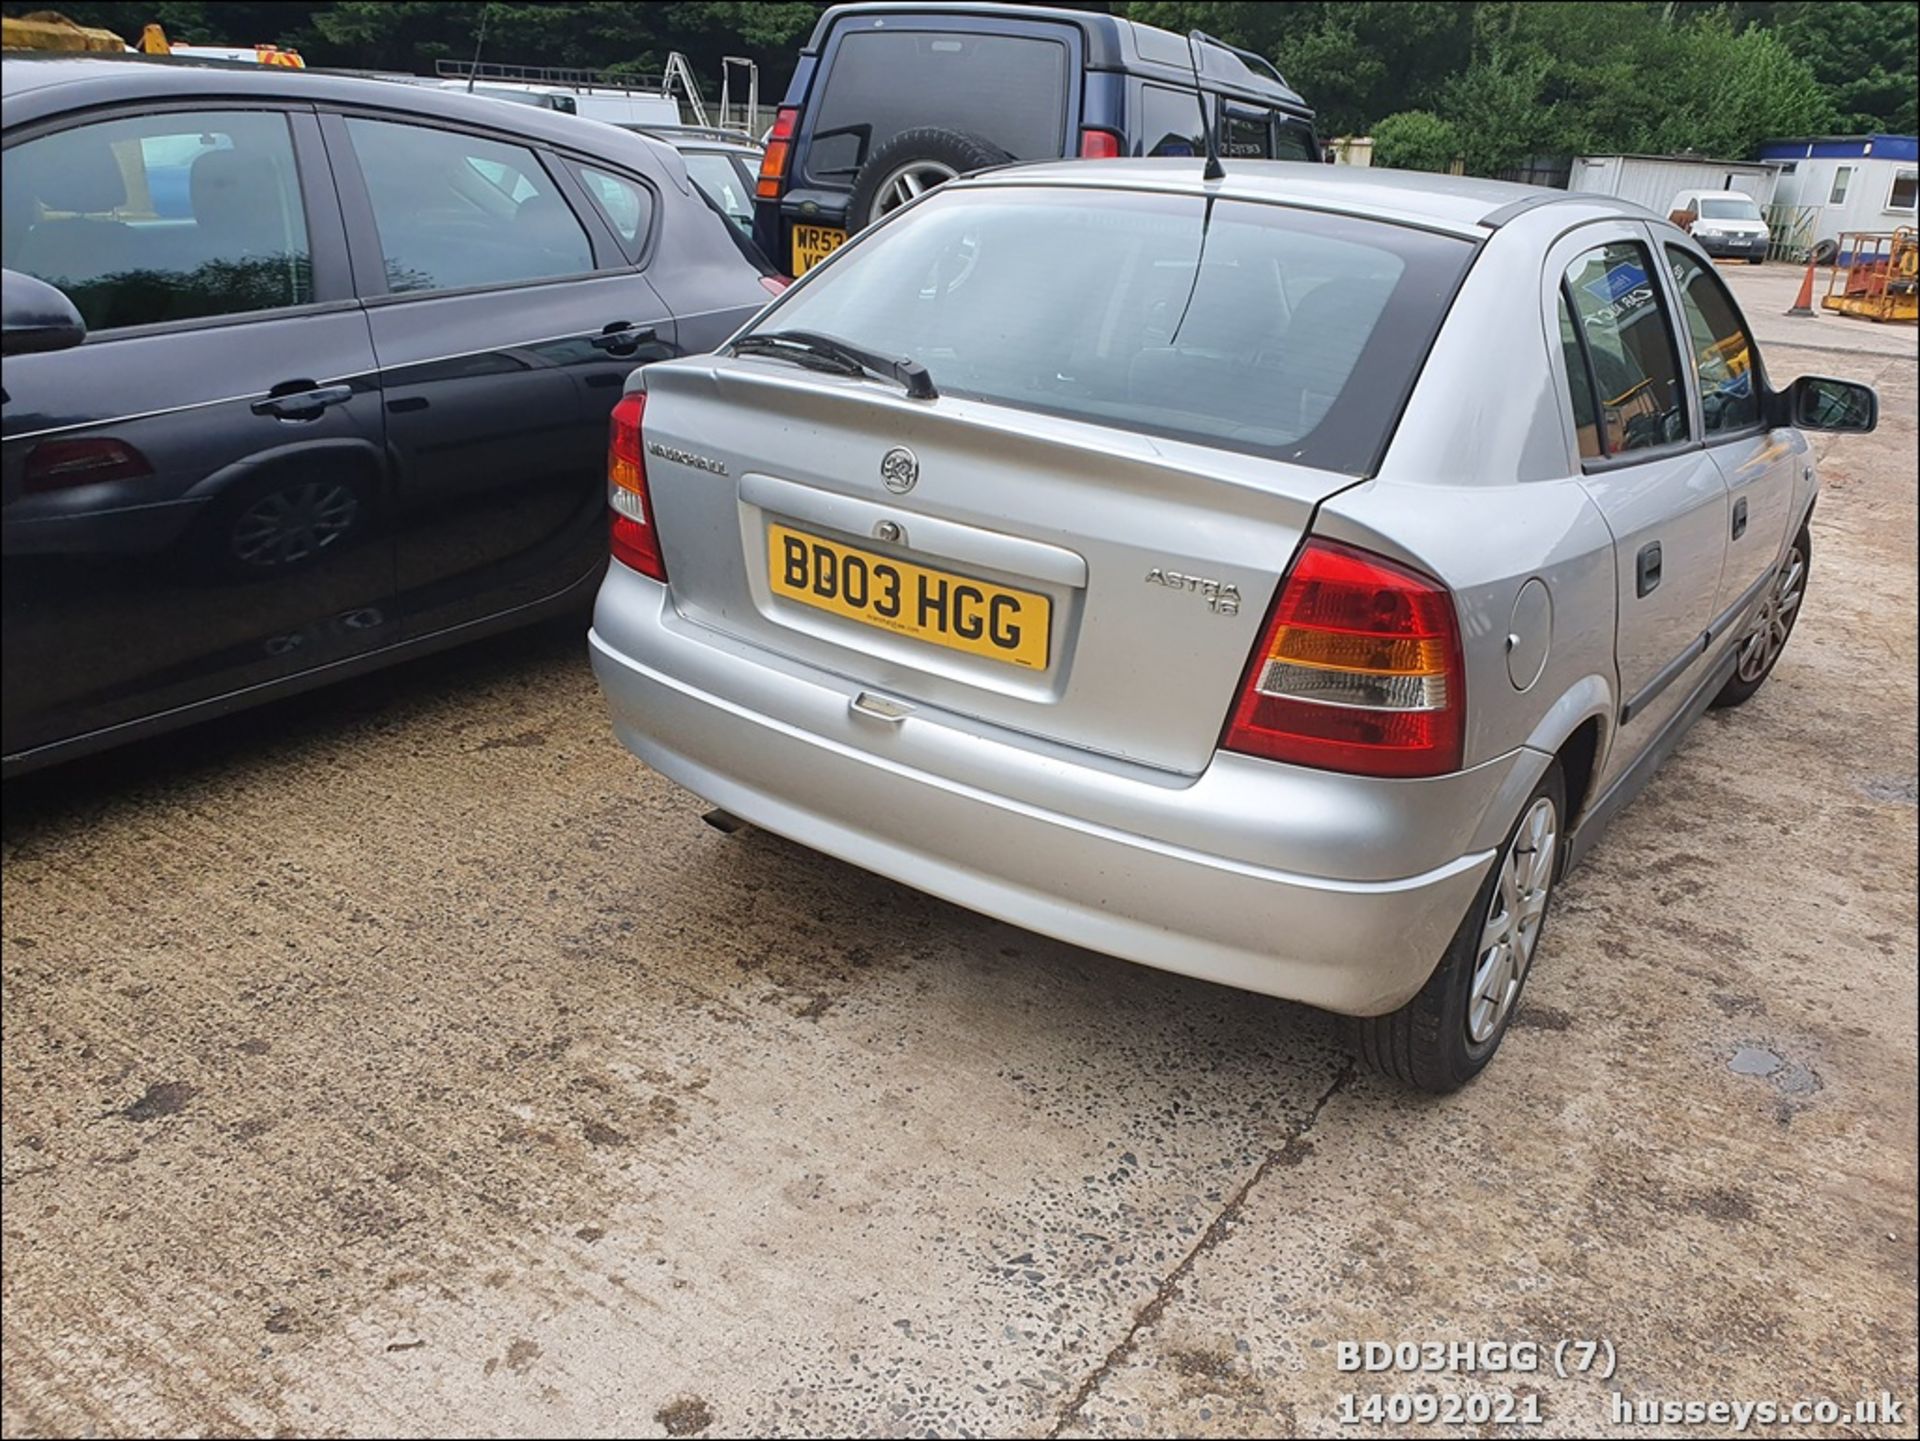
[589,566,1548,1015]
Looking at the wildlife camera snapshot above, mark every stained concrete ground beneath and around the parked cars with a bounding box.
[0,267,1920,1435]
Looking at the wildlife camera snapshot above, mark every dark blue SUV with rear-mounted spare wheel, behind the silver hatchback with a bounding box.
[755,4,1321,274]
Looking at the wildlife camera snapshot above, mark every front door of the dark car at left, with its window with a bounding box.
[0,100,394,760]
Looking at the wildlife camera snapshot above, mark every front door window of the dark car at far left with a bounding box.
[0,111,313,330]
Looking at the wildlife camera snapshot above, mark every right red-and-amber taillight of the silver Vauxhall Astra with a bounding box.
[1221,539,1467,775]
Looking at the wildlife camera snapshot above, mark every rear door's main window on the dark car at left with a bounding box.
[348,117,593,294]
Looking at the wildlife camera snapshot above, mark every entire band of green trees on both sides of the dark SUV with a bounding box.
[11,0,1920,173]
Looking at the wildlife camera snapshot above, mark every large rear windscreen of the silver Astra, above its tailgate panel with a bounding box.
[756,186,1473,476]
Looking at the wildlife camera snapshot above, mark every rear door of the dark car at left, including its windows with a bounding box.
[321,111,674,637]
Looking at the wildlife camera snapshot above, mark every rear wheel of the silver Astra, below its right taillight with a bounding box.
[1357,762,1567,1094]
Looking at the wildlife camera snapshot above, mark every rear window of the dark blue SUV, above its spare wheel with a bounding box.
[806,31,1068,186]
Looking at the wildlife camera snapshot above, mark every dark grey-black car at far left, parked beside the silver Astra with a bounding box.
[0,56,776,773]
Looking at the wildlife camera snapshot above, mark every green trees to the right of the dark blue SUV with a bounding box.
[1116,0,1896,175]
